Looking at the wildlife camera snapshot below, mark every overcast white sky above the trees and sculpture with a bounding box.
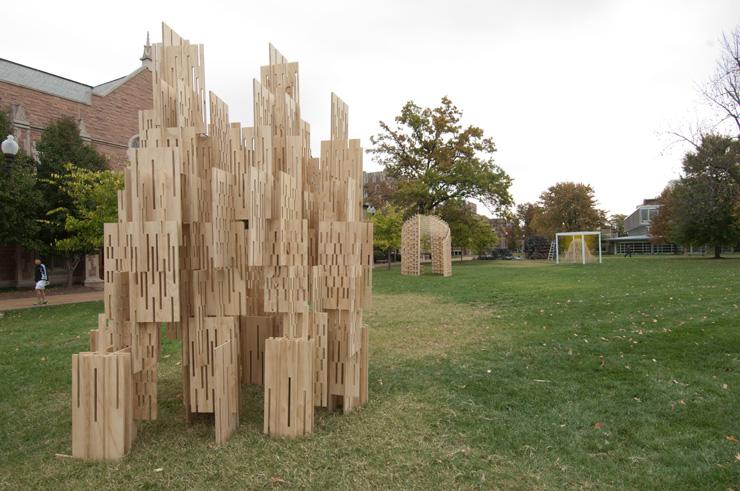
[5,0,740,214]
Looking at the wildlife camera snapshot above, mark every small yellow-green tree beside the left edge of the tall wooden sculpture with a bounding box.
[48,164,123,286]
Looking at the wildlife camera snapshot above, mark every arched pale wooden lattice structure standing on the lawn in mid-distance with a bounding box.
[401,215,452,276]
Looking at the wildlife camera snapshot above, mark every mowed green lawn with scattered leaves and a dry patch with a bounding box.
[0,257,740,490]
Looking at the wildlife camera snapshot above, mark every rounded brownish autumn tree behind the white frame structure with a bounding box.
[539,182,606,237]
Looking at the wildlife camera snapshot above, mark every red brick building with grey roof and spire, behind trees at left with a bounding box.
[0,39,152,287]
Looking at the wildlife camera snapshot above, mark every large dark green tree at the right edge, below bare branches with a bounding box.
[650,135,740,258]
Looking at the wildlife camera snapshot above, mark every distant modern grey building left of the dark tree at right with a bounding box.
[602,199,678,254]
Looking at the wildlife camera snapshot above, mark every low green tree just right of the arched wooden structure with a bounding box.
[439,200,498,254]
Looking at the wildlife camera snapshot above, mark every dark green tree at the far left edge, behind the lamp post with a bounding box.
[0,111,41,249]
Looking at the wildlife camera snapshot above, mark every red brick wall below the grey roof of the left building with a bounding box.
[0,70,153,168]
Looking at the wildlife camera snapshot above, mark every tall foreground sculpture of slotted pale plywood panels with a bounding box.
[72,25,373,459]
